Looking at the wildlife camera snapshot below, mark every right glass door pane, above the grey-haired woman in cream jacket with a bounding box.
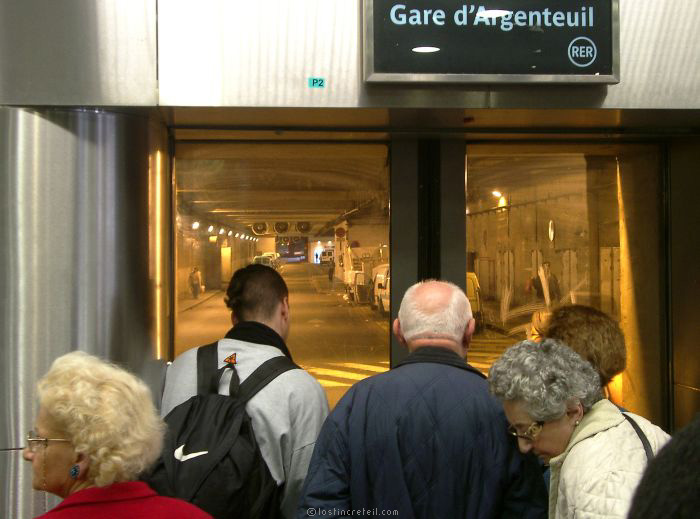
[466,144,663,415]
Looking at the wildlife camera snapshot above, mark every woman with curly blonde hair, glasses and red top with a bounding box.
[24,351,211,519]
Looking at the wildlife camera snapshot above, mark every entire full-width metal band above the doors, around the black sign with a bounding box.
[0,0,700,109]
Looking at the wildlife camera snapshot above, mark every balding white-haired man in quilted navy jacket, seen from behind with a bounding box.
[297,280,547,519]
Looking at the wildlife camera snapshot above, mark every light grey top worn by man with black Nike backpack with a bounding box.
[161,339,328,518]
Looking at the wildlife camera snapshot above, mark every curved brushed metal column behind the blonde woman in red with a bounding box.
[0,107,170,518]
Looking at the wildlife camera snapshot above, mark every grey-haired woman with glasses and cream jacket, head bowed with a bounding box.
[489,339,669,519]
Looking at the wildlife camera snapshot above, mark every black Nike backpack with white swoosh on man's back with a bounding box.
[142,343,298,519]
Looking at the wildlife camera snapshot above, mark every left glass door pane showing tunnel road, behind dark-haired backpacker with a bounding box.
[175,143,391,406]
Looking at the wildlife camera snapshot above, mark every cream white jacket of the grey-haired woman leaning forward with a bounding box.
[549,400,669,519]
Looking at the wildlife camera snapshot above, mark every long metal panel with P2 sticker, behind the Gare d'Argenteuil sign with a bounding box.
[158,0,700,109]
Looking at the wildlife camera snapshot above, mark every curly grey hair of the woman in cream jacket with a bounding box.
[489,339,602,421]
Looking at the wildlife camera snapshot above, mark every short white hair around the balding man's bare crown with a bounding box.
[399,279,472,343]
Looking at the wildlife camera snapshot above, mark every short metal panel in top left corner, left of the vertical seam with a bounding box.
[0,0,158,106]
